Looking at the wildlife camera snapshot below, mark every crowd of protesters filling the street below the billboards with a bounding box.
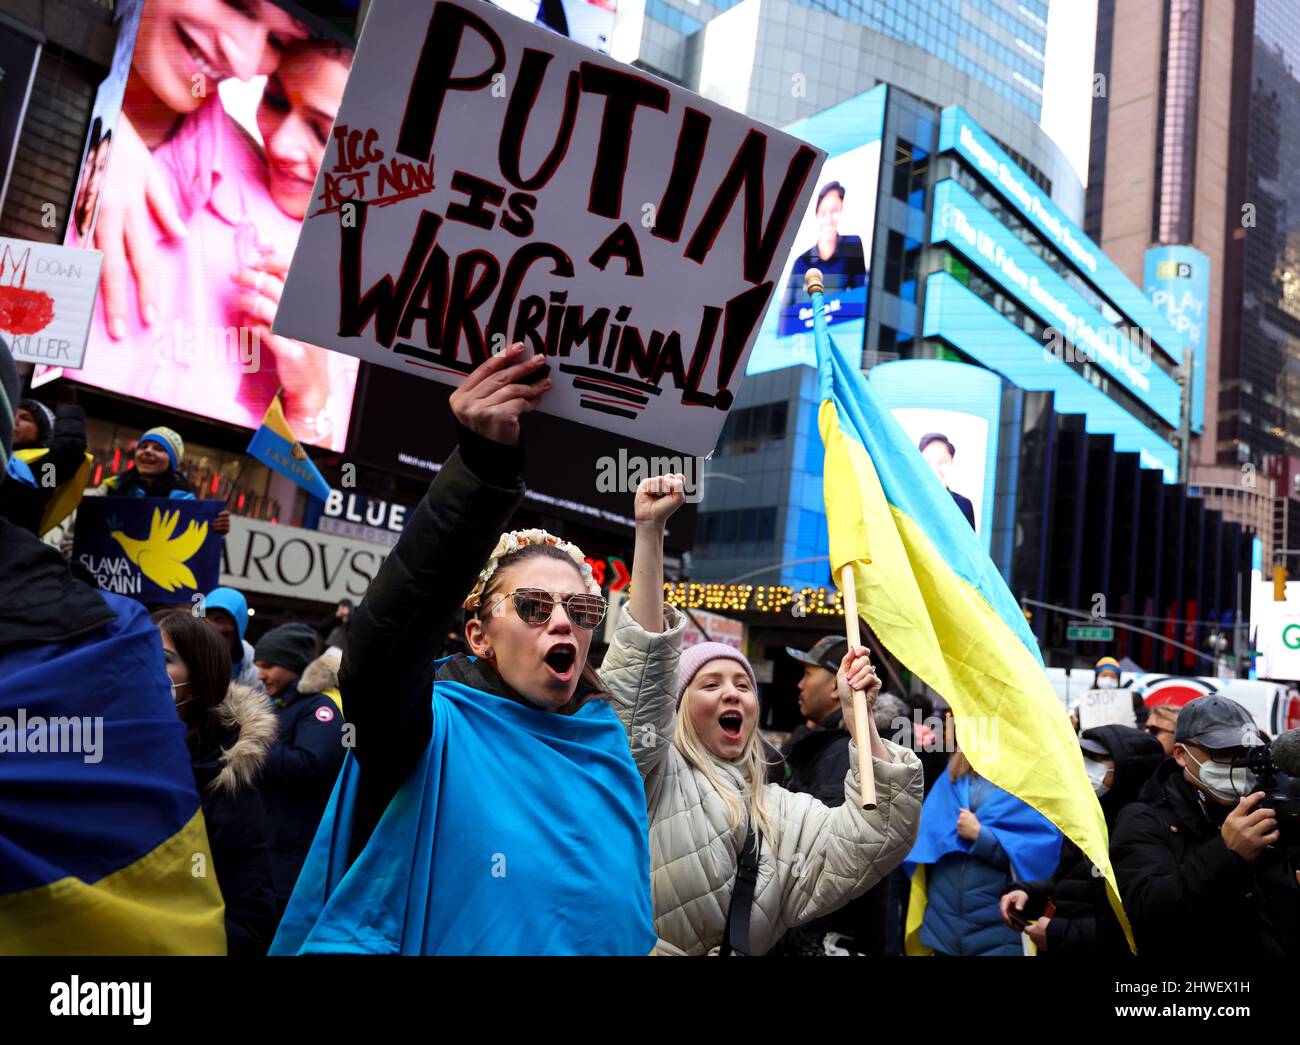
[0,350,1300,958]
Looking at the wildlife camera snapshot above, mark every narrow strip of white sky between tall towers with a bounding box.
[1041,0,1097,185]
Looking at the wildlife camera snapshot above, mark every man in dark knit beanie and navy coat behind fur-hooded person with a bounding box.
[252,623,346,915]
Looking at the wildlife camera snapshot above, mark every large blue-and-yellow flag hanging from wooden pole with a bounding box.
[813,271,1132,946]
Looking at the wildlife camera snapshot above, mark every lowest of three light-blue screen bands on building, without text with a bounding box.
[922,272,1178,482]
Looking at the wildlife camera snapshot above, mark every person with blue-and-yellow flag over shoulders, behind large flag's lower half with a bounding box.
[904,733,1061,955]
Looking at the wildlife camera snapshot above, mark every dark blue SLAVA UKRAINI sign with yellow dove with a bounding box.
[73,497,226,603]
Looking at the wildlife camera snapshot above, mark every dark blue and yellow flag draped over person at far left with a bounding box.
[0,591,226,955]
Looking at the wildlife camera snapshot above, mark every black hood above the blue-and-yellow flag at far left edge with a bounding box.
[0,519,117,650]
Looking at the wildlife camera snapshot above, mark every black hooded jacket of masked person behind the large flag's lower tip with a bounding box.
[1009,725,1165,957]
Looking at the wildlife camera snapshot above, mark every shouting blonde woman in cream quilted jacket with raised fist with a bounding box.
[601,476,922,954]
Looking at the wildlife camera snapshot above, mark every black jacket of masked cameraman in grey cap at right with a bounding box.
[1110,759,1300,961]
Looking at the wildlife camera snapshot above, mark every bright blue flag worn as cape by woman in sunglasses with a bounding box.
[270,681,655,954]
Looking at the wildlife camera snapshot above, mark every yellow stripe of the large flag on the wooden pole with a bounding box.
[819,400,1134,948]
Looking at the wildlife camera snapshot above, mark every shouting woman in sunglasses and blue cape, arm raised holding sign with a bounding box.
[272,344,676,954]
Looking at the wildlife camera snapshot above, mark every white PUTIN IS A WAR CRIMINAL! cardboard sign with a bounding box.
[274,0,826,454]
